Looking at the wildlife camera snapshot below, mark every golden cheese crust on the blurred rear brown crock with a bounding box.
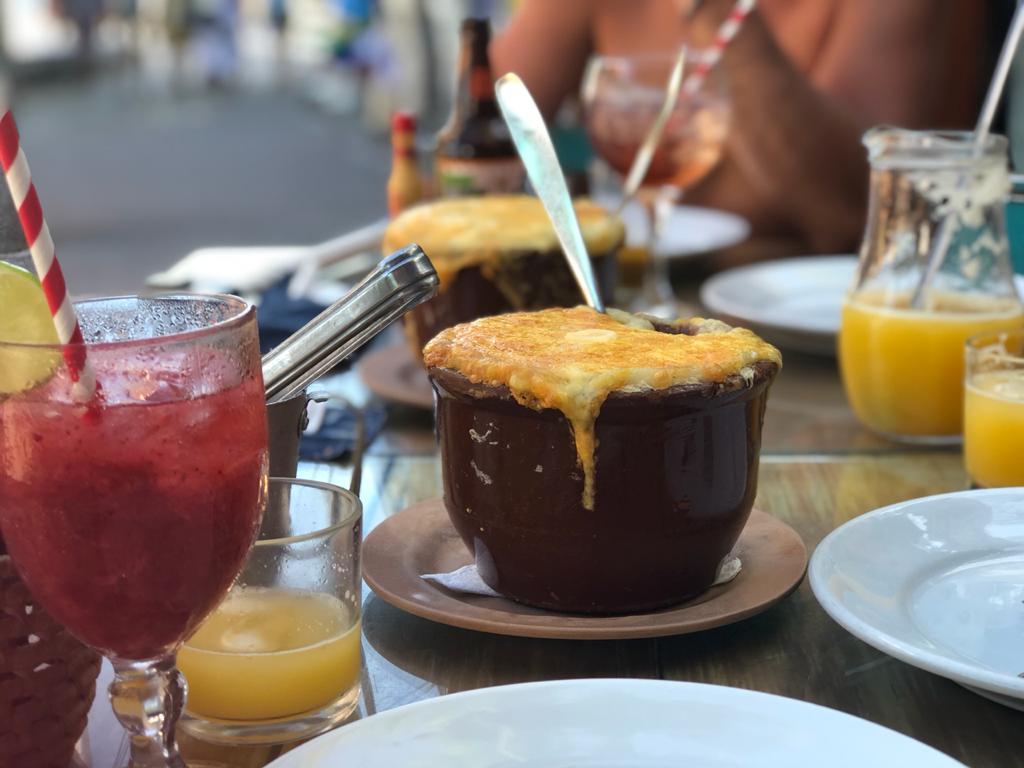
[383,195,626,286]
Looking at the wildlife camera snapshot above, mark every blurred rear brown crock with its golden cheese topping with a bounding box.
[383,195,625,357]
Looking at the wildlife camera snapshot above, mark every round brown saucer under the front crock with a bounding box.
[362,499,807,640]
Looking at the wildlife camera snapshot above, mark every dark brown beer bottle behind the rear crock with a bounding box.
[435,18,525,198]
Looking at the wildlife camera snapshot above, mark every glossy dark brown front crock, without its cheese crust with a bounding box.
[428,310,779,613]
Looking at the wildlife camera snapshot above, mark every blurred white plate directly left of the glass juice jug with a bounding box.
[700,256,857,355]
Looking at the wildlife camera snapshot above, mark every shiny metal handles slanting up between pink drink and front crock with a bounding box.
[263,245,438,402]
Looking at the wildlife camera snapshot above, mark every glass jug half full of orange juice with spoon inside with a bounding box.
[839,127,1024,443]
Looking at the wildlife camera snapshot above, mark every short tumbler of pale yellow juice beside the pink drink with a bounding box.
[178,478,362,744]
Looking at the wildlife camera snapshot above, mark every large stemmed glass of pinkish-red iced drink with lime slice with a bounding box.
[0,295,267,768]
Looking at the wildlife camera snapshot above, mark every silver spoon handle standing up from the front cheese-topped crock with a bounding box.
[495,73,604,312]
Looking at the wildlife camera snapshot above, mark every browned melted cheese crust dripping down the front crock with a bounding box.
[423,306,782,509]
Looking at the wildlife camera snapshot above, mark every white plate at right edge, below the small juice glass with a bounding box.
[809,488,1024,709]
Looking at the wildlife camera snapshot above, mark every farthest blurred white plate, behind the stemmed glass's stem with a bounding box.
[595,195,751,259]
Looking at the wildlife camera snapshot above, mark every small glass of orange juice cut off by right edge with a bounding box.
[964,330,1024,487]
